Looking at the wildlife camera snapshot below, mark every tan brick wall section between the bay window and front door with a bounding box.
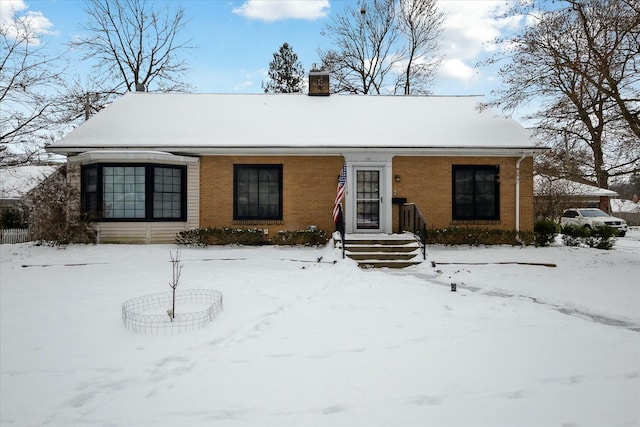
[200,156,344,235]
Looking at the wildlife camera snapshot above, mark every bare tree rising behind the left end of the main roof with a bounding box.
[73,0,191,92]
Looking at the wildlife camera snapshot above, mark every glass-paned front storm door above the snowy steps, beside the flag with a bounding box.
[356,168,382,232]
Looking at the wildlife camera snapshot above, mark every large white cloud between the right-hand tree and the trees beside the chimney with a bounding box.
[438,0,522,81]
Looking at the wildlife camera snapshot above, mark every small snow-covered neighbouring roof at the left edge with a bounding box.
[0,165,60,200]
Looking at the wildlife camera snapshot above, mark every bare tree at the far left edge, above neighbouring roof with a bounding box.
[0,16,62,164]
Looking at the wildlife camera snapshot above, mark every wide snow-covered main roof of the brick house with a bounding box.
[48,92,536,154]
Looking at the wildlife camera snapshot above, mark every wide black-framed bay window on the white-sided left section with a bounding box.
[81,164,187,221]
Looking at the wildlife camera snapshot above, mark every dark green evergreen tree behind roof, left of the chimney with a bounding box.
[262,42,304,93]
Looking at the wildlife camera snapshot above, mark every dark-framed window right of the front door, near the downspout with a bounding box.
[452,165,500,220]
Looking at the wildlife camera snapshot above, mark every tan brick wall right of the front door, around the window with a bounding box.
[393,156,534,231]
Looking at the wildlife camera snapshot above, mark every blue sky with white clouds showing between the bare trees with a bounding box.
[0,0,521,95]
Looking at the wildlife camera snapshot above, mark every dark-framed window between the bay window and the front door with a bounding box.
[233,165,282,220]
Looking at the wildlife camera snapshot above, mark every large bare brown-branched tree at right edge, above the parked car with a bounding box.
[485,0,640,188]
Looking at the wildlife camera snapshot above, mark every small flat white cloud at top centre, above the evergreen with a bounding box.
[233,0,331,22]
